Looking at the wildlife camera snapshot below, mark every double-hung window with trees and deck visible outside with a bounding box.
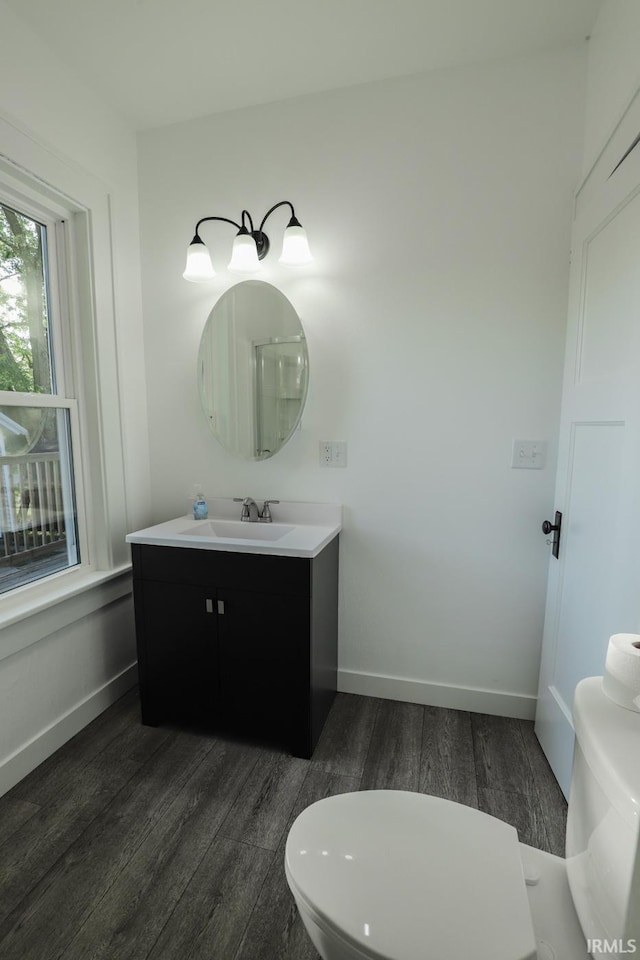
[0,201,84,594]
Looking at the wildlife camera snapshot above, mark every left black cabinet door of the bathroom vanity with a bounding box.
[136,580,219,724]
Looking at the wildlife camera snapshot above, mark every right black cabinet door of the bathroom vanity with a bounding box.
[218,590,309,755]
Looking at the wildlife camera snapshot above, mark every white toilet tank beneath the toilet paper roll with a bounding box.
[566,677,640,958]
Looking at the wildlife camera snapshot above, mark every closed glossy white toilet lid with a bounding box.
[285,790,536,960]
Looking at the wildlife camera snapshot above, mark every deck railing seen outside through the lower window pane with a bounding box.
[0,452,65,557]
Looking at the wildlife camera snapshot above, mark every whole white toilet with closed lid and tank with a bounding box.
[285,677,640,960]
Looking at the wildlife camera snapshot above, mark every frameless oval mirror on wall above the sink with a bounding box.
[198,280,309,460]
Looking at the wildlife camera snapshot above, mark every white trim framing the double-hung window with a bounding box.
[0,117,130,640]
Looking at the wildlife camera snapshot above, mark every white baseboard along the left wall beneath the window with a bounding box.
[0,663,138,796]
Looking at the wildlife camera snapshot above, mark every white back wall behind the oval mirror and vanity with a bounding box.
[139,50,584,716]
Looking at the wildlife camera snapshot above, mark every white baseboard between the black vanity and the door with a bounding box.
[338,670,536,720]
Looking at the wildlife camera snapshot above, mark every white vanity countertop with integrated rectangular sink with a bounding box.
[126,498,342,557]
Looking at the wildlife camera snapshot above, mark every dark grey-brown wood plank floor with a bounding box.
[0,692,566,960]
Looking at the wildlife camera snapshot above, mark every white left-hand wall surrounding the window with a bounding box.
[0,0,149,793]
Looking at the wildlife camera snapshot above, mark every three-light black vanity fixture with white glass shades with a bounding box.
[182,200,313,283]
